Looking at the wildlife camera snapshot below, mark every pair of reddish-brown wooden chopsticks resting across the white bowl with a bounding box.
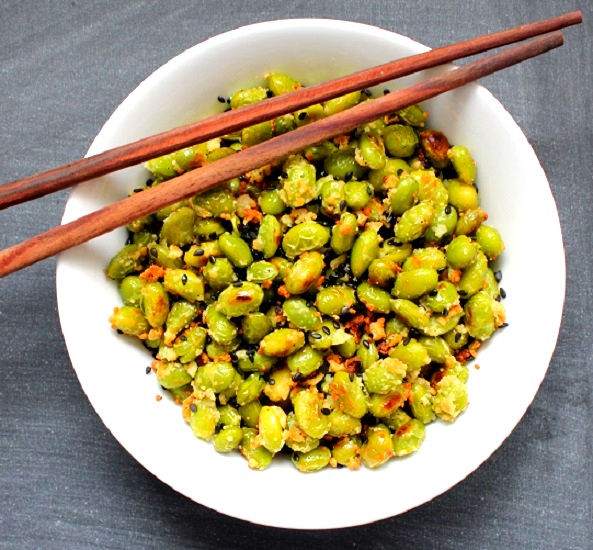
[0,11,582,277]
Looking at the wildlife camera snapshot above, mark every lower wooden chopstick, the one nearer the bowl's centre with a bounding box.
[0,32,563,277]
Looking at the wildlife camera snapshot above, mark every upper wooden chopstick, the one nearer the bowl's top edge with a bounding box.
[0,11,583,210]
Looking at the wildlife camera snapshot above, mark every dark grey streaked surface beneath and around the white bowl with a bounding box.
[0,0,593,549]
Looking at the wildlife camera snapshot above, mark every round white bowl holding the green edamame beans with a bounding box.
[57,19,565,529]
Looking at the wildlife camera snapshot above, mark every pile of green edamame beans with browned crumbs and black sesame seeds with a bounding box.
[106,74,506,472]
